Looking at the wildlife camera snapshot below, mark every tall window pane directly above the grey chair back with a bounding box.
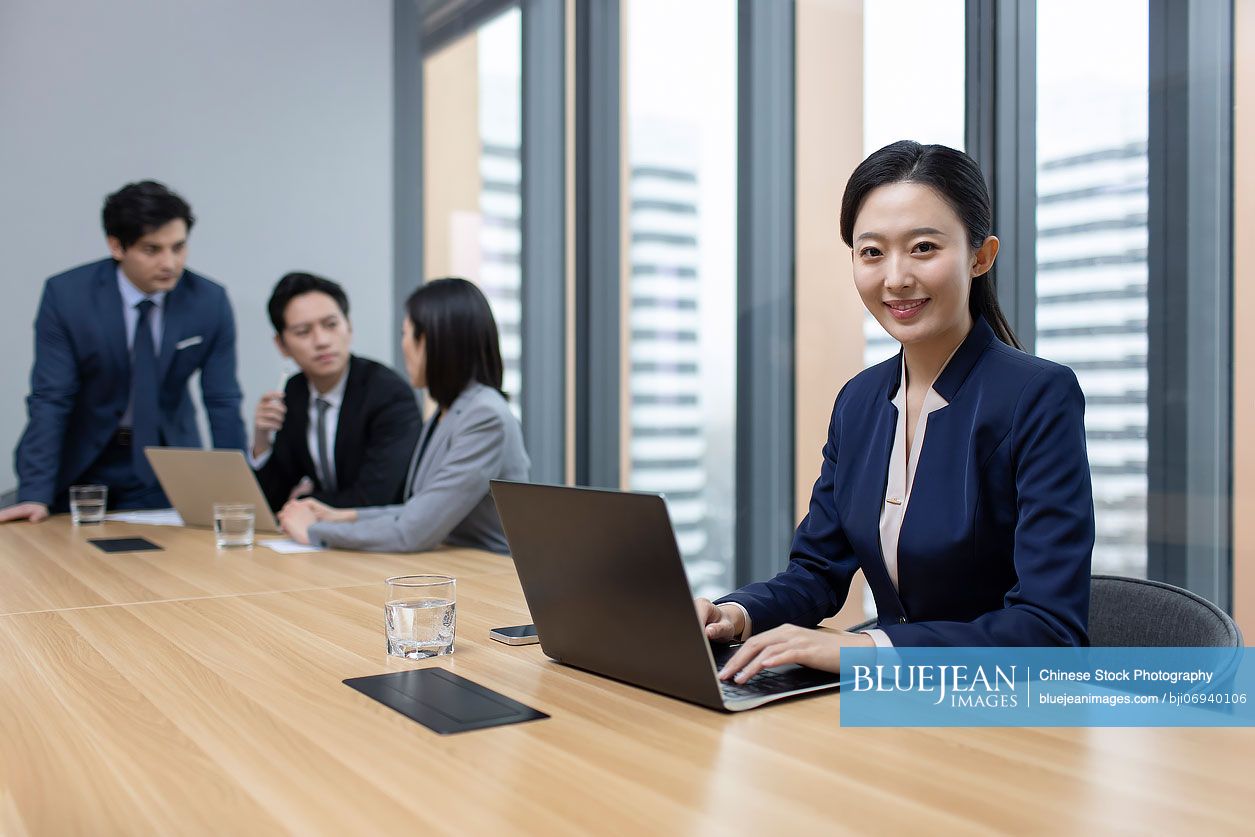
[1035,0,1148,577]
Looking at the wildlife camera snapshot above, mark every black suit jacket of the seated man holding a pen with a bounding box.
[257,356,423,511]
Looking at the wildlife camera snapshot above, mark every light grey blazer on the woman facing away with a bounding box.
[309,383,531,552]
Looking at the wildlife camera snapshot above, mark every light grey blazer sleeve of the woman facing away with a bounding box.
[309,407,506,552]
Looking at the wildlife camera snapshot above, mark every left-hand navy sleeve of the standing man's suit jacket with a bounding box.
[14,285,79,506]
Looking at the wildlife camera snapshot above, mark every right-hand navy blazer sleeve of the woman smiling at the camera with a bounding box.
[881,366,1094,646]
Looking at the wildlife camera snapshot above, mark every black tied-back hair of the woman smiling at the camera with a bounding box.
[841,139,1024,349]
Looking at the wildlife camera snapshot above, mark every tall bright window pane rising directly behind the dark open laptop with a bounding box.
[622,0,737,595]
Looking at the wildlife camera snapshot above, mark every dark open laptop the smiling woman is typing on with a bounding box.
[492,479,840,712]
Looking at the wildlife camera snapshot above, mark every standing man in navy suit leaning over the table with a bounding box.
[0,181,246,522]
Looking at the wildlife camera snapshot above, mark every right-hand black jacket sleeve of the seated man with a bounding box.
[314,375,423,508]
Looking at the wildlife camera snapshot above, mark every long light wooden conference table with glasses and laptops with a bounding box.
[0,518,1255,834]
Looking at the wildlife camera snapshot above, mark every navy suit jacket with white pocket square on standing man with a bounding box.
[14,259,245,506]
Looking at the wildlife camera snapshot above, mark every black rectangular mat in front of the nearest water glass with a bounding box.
[344,669,548,735]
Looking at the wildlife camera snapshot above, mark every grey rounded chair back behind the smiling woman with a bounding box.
[850,576,1242,648]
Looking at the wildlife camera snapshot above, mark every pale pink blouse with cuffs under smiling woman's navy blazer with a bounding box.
[724,344,963,648]
